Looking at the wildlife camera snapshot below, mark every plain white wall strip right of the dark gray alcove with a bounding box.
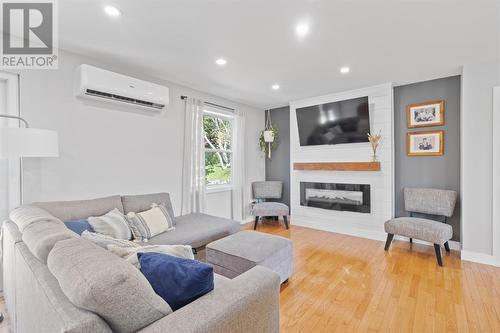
[461,62,500,261]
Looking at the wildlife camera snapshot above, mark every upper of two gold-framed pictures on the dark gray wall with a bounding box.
[406,100,444,128]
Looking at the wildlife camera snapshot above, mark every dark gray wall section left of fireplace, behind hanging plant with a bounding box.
[266,106,290,206]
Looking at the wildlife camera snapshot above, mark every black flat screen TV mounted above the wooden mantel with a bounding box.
[295,97,370,146]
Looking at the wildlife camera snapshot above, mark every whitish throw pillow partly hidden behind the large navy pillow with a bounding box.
[108,245,194,268]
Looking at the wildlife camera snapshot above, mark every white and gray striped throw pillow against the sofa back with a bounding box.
[127,204,175,242]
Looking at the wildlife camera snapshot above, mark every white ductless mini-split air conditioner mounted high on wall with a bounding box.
[76,64,169,111]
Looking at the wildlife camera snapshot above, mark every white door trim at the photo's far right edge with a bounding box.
[492,86,500,266]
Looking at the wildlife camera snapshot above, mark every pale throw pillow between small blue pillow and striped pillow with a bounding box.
[88,208,132,239]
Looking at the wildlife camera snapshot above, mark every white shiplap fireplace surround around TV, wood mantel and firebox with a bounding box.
[290,83,394,240]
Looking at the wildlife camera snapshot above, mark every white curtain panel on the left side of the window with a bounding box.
[182,98,205,214]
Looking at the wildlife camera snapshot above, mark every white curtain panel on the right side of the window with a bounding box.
[232,110,247,221]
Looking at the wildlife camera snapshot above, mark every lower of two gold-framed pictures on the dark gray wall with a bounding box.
[406,131,444,156]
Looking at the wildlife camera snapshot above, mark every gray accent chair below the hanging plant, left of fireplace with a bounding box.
[250,181,290,230]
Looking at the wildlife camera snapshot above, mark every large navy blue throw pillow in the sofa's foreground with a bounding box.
[137,252,214,311]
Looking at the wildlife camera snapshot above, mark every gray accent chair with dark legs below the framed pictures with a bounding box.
[384,188,458,266]
